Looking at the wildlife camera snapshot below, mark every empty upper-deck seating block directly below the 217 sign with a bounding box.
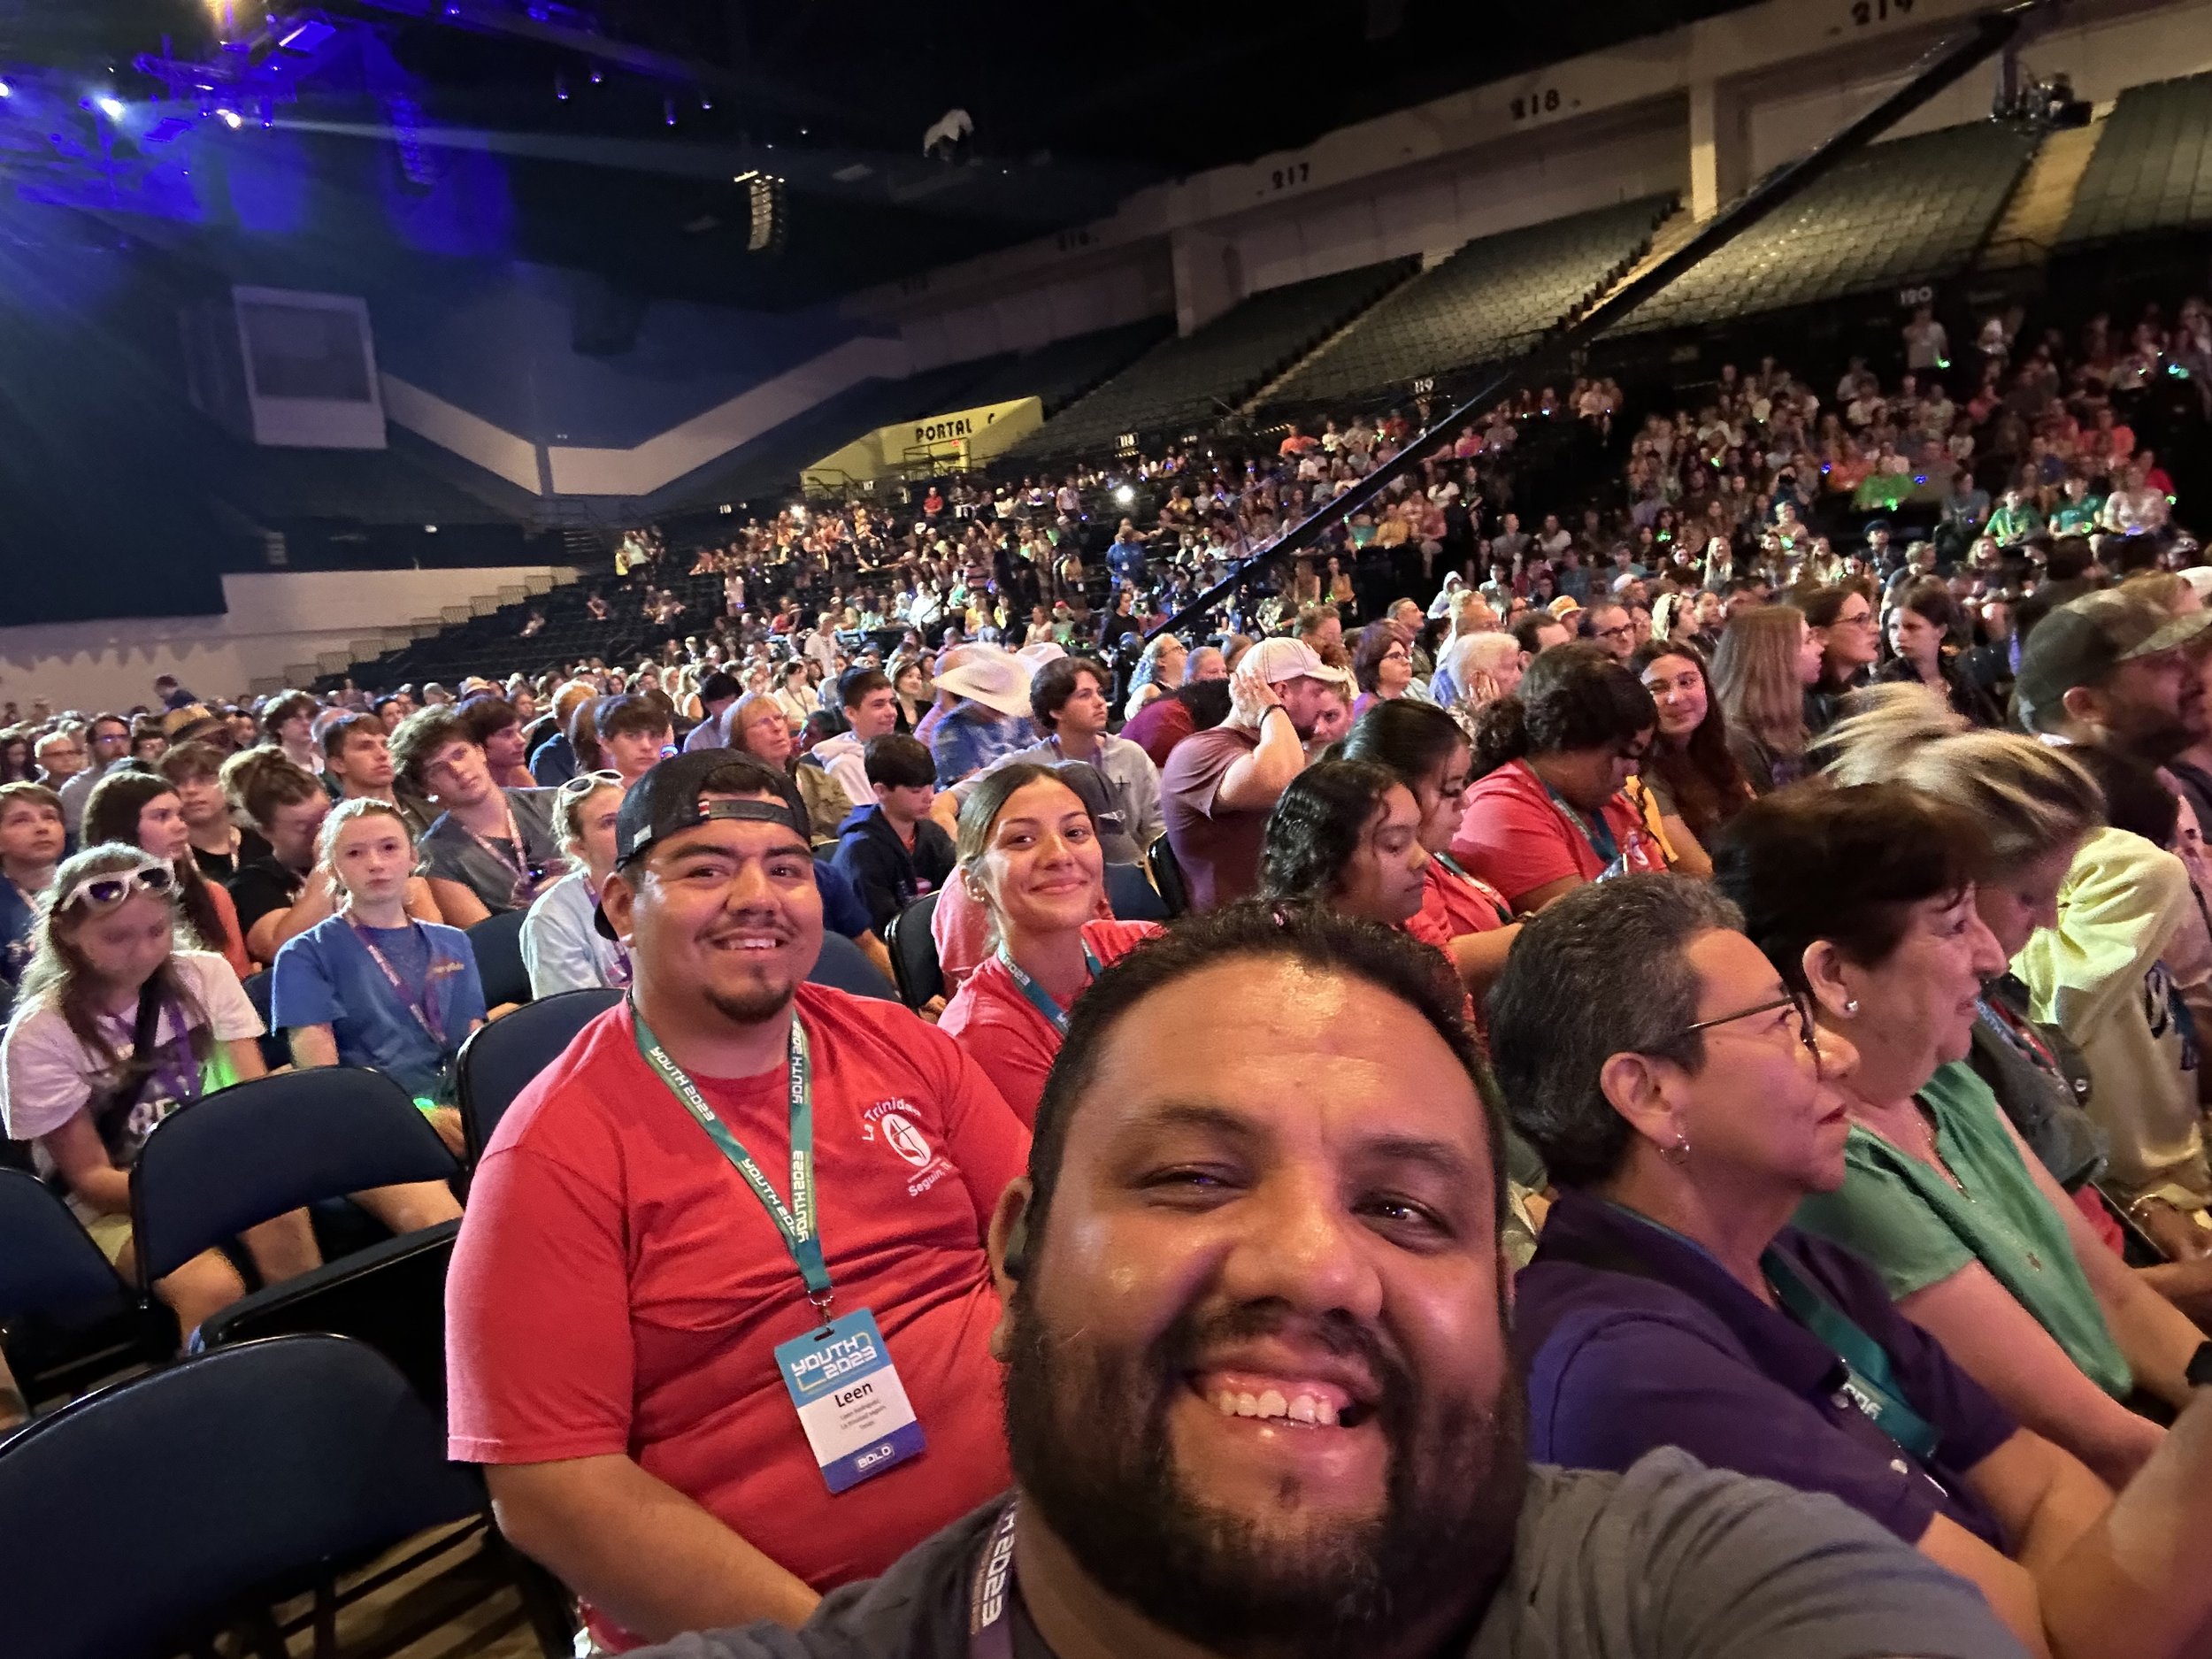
[1009,259,1414,463]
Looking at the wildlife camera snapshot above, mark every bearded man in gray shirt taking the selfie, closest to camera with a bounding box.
[624,905,2020,1659]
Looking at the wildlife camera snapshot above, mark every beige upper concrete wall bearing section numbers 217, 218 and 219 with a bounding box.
[845,0,2212,347]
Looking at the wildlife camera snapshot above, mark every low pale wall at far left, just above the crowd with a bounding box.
[0,566,551,712]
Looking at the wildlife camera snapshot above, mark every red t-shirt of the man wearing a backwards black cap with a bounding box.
[447,985,1029,1648]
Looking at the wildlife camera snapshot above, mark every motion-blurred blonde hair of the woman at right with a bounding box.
[1816,686,2104,872]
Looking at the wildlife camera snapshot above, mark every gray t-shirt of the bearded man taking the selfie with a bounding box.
[633,1449,2022,1659]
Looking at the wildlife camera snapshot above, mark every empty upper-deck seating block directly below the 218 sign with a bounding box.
[1268,197,1675,410]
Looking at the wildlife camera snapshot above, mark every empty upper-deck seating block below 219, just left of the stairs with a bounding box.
[1613,122,2035,334]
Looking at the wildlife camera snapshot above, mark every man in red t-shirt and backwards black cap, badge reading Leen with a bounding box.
[447,750,1029,1650]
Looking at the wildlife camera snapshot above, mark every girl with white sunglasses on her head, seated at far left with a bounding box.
[0,843,321,1334]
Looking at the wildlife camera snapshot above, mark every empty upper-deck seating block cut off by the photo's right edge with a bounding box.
[2060,75,2212,248]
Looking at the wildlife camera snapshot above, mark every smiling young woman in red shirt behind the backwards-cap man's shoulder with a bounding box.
[938,761,1159,1124]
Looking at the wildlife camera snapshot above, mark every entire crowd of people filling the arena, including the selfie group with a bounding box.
[0,283,2212,1659]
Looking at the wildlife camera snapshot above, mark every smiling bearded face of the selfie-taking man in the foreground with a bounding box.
[994,958,1525,1646]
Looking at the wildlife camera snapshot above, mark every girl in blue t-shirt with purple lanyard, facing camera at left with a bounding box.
[270,799,485,1233]
